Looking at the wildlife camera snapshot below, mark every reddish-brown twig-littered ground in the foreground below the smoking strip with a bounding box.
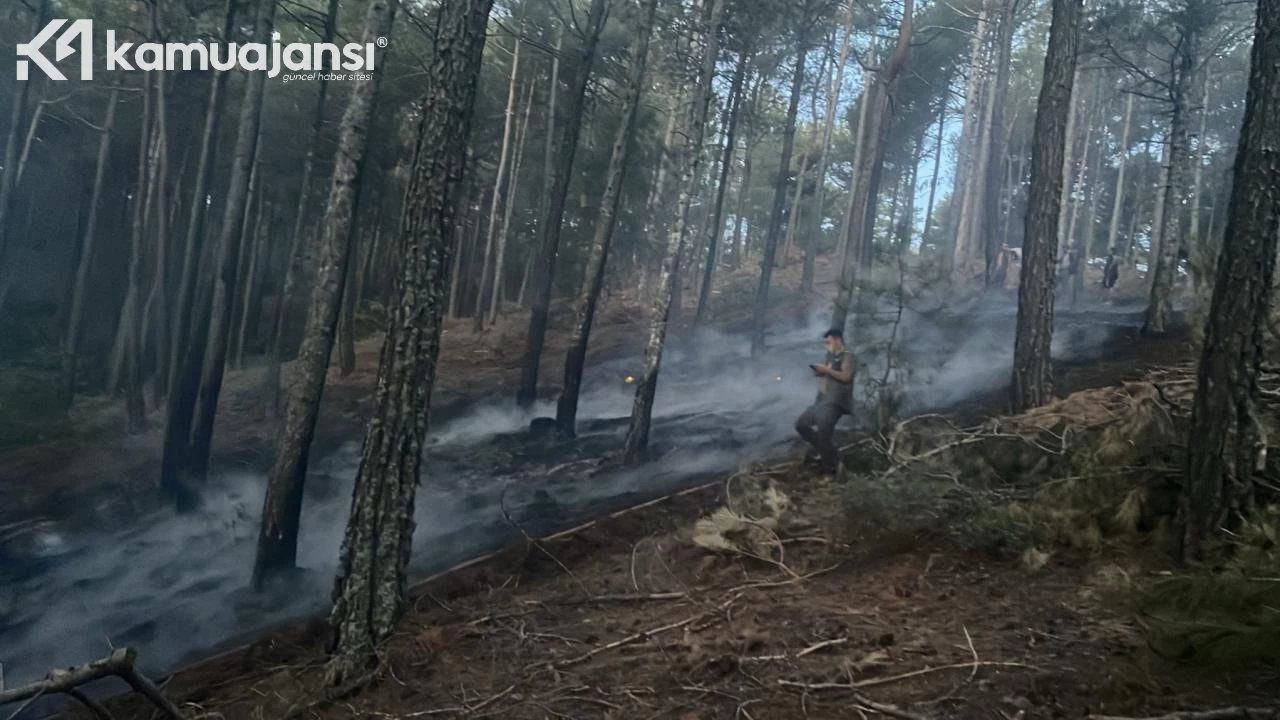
[52,322,1277,720]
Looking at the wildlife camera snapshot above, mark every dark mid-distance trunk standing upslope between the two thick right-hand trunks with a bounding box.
[1142,19,1198,334]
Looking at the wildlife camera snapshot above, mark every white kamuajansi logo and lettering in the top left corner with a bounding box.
[17,19,387,81]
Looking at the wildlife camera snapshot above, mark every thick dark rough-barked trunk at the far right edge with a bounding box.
[1180,0,1280,560]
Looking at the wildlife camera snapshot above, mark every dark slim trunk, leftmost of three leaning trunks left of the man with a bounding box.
[516,0,605,407]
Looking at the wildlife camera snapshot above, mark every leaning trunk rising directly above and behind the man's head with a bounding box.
[831,0,915,329]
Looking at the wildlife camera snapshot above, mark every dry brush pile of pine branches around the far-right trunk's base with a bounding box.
[844,365,1280,669]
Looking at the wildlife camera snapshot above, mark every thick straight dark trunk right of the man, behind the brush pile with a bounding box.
[1010,0,1083,413]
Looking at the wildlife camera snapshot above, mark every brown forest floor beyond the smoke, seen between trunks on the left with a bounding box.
[0,258,835,532]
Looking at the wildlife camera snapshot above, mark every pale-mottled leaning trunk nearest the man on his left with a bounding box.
[623,0,724,464]
